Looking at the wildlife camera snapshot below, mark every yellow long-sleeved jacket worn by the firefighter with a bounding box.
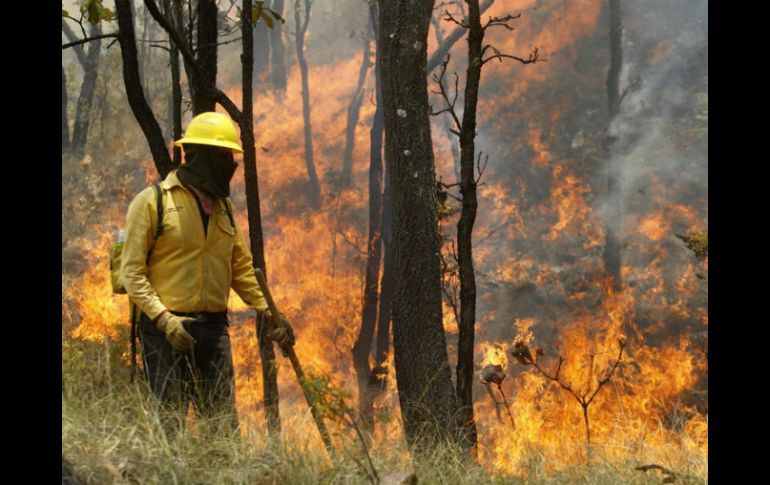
[120,171,267,319]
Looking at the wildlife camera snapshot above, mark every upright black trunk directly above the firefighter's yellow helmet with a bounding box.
[193,0,217,115]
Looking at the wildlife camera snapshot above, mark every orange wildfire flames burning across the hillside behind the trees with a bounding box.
[63,0,708,477]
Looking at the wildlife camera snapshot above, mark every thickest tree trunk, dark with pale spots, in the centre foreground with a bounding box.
[379,0,457,451]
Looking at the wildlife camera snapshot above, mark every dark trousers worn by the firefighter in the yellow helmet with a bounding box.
[138,314,238,430]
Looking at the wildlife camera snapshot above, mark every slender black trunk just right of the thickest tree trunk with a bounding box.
[457,0,484,458]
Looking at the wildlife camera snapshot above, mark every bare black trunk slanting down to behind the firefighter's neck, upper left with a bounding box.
[115,0,173,179]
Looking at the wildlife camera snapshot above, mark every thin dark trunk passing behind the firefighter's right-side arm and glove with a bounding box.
[239,0,281,443]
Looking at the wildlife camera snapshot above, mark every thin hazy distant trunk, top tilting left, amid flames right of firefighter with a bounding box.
[294,0,321,207]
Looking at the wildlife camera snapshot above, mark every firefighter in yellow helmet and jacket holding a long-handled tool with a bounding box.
[120,112,293,430]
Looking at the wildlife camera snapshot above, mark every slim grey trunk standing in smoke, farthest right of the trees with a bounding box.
[603,0,623,291]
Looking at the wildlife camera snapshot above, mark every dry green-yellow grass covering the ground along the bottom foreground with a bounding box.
[62,338,708,485]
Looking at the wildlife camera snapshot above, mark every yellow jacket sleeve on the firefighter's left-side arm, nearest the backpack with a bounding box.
[120,187,166,320]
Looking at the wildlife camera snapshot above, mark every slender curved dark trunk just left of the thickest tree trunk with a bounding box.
[353,4,382,433]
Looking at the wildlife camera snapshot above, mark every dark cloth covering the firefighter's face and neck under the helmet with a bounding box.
[177,144,238,198]
